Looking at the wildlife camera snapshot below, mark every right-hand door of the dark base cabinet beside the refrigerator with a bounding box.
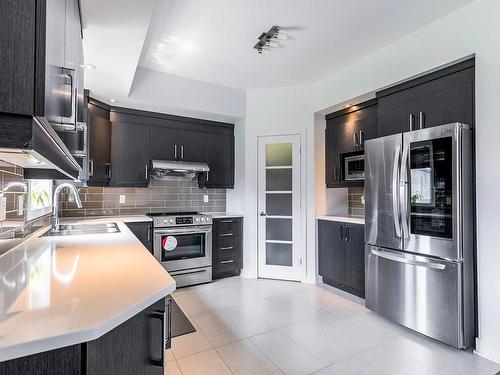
[345,225,365,297]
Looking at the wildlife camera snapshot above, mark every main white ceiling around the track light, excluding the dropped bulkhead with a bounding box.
[139,0,471,89]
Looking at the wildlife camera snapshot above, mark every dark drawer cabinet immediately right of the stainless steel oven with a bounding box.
[212,217,243,279]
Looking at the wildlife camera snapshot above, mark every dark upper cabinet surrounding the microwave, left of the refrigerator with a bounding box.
[325,100,377,188]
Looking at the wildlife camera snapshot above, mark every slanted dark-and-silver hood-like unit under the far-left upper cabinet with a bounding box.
[0,114,81,180]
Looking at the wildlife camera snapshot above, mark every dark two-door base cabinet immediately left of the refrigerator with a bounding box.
[318,220,365,298]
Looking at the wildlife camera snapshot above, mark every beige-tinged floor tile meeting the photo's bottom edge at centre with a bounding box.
[217,339,282,375]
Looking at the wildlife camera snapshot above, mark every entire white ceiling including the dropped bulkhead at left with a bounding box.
[80,0,473,117]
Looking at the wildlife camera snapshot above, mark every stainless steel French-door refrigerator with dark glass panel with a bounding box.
[365,123,475,348]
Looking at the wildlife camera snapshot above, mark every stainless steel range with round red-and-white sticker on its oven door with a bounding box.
[147,212,212,287]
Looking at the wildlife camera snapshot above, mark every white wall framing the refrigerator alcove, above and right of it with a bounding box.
[308,0,500,362]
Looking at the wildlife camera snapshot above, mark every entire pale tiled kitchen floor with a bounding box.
[166,278,500,375]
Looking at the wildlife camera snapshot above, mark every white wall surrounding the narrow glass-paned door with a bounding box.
[227,85,316,282]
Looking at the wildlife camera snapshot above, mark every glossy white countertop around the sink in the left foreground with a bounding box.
[0,217,175,361]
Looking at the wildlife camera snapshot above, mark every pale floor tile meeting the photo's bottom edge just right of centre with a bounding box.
[251,330,324,375]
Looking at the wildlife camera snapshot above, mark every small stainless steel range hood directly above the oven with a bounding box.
[151,160,210,181]
